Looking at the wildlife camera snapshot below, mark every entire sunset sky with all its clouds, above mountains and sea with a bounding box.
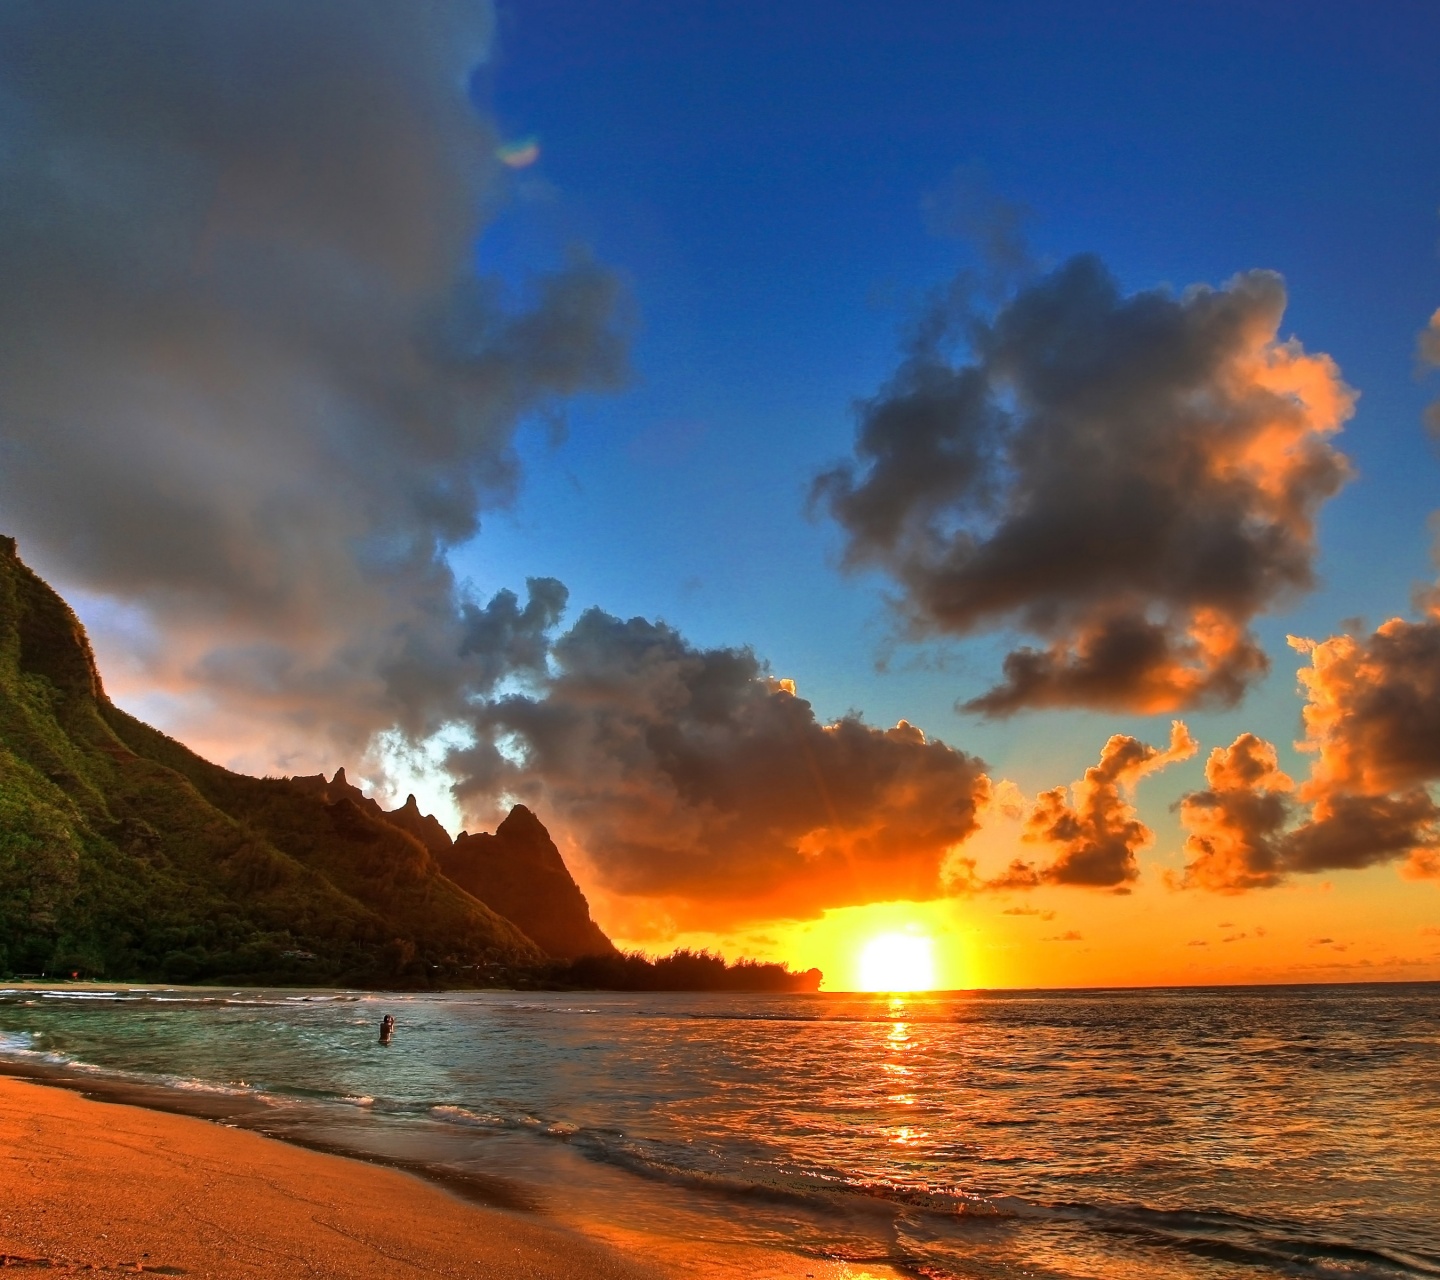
[0,0,1440,988]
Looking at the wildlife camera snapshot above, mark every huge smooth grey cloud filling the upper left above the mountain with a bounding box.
[0,0,625,771]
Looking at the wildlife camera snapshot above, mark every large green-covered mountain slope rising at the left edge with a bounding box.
[0,538,544,985]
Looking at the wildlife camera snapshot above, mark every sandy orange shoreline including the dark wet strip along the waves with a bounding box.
[0,1057,912,1280]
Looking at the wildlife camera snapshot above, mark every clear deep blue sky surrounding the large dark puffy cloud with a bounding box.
[456,3,1440,785]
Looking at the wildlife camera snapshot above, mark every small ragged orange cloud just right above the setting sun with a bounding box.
[992,720,1197,888]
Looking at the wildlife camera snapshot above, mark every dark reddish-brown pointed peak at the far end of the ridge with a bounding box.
[440,796,616,960]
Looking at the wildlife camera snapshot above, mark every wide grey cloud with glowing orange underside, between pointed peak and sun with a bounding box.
[448,609,992,929]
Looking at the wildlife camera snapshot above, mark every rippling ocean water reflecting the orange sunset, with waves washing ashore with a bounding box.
[0,983,1440,1280]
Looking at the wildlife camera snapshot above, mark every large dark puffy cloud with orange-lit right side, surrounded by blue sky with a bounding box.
[812,258,1354,716]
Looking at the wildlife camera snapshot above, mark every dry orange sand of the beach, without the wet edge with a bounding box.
[0,1078,665,1280]
